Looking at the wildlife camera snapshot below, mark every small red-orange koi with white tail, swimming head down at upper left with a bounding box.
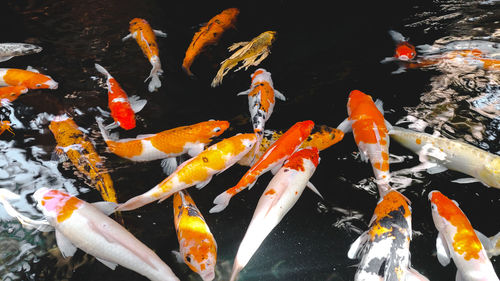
[95,63,147,130]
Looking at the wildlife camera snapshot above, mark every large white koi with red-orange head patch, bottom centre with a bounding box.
[230,148,319,281]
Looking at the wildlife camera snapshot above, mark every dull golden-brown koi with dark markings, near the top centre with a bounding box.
[212,31,276,87]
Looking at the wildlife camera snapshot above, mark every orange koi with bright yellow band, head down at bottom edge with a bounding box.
[173,190,217,281]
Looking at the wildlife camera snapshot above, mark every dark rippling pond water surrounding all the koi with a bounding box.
[0,0,500,281]
